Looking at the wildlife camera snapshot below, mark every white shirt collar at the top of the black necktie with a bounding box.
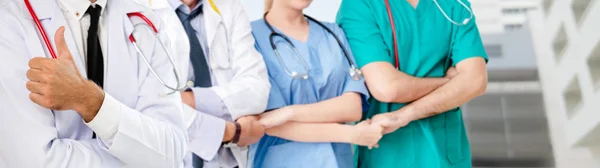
[58,0,107,20]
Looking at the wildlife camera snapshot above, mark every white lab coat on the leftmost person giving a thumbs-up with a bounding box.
[0,0,187,168]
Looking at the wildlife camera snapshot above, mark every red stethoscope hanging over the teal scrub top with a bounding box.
[384,0,473,69]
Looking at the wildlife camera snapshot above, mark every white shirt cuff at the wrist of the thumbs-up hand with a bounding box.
[85,93,121,147]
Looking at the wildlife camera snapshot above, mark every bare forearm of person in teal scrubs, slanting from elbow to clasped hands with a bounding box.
[399,70,487,120]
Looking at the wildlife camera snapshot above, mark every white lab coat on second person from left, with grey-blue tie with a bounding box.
[134,0,271,168]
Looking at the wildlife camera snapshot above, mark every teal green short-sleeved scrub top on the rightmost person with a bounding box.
[337,0,487,168]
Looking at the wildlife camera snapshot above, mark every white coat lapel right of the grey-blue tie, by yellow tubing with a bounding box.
[202,0,223,47]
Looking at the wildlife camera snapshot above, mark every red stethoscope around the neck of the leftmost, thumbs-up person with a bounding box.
[23,0,193,95]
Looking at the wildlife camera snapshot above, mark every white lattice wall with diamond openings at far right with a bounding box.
[529,0,600,168]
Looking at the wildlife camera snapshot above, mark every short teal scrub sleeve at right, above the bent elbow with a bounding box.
[451,0,488,66]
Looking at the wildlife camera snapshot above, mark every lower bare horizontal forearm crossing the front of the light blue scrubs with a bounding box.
[266,122,355,143]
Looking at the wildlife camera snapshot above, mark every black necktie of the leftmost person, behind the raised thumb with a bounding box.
[85,5,104,138]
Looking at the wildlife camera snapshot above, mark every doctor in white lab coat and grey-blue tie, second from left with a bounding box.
[142,0,270,168]
